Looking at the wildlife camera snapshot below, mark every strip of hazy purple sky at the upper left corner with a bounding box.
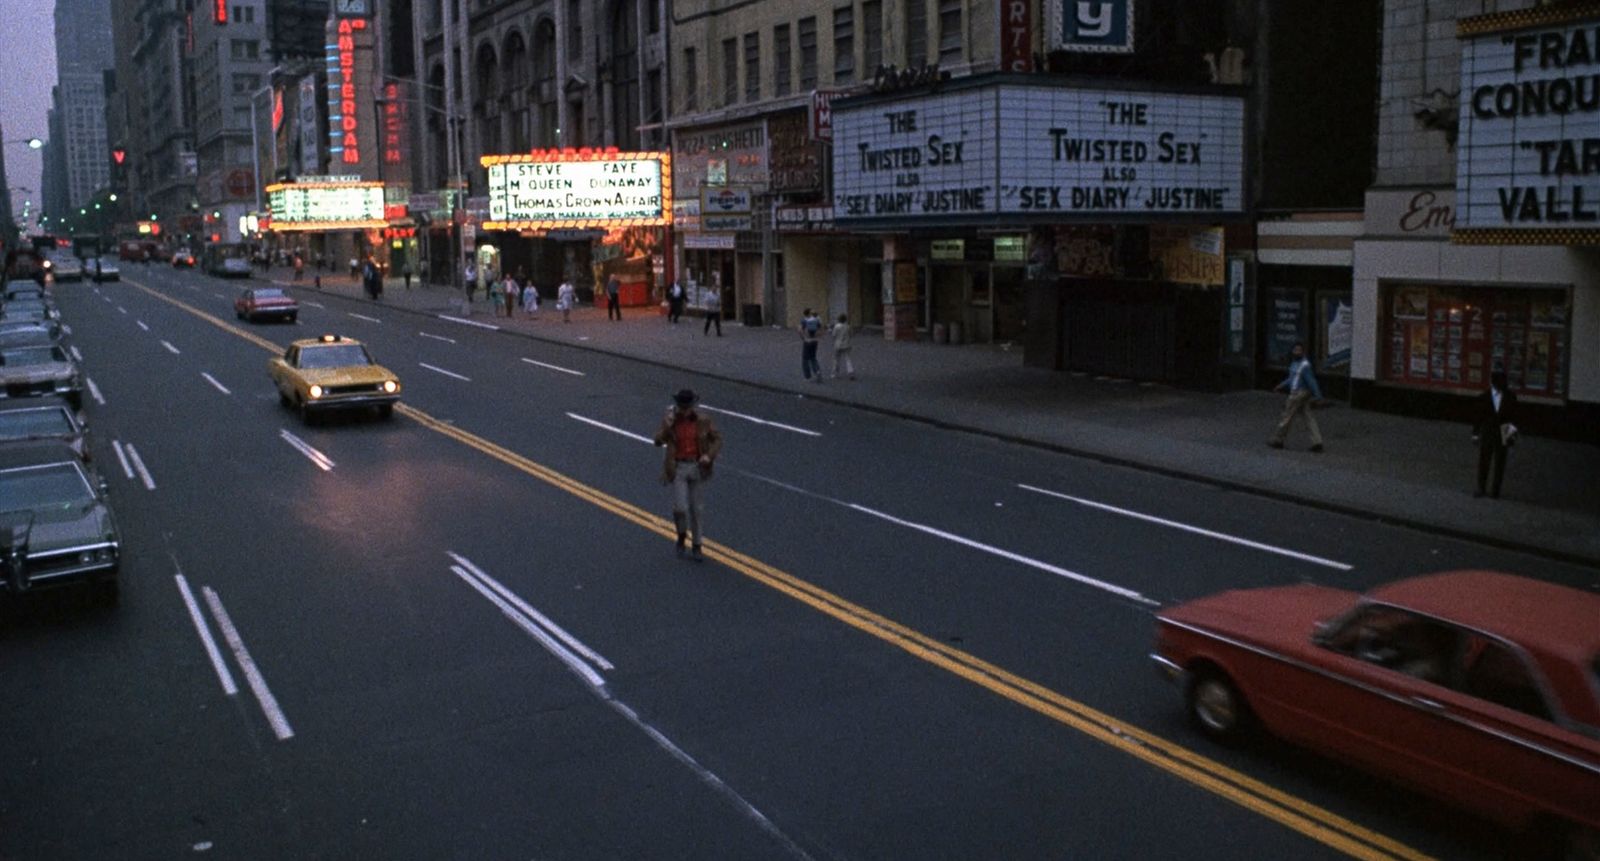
[0,0,60,224]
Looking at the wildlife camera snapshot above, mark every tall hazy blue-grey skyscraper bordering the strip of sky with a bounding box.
[56,0,112,208]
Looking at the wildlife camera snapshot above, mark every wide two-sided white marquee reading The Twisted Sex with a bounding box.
[834,83,1245,227]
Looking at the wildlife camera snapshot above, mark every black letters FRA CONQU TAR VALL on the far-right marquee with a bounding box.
[1469,27,1600,226]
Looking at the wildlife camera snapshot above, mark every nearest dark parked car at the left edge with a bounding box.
[0,442,122,605]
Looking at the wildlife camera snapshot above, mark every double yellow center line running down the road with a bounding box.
[133,282,1429,861]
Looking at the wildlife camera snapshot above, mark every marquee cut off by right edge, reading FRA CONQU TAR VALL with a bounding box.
[1451,6,1600,245]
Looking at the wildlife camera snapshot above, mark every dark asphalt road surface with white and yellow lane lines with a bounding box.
[0,266,1600,859]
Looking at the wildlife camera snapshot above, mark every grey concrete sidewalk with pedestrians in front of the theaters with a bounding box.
[272,269,1600,567]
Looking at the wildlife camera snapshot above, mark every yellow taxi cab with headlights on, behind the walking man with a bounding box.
[267,334,400,424]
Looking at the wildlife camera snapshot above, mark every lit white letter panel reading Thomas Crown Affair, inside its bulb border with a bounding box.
[490,160,661,221]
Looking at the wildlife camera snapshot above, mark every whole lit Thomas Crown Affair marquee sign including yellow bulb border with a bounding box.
[480,149,672,230]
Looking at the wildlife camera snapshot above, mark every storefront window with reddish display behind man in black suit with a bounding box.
[1381,285,1571,398]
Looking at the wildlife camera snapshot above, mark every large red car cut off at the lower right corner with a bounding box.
[1152,571,1600,859]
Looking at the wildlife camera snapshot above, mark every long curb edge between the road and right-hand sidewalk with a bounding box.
[272,282,1600,568]
